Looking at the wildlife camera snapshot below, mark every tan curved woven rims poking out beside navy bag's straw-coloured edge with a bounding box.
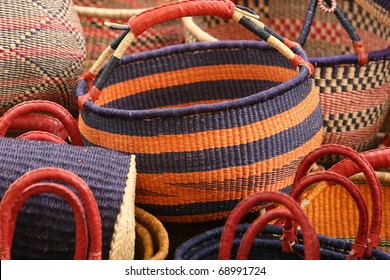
[134,207,169,260]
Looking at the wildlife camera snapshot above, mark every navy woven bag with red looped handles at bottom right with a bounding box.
[175,152,390,260]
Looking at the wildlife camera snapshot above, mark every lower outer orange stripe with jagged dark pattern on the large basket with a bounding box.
[136,130,322,205]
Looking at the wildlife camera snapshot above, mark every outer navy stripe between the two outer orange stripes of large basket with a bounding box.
[80,105,322,174]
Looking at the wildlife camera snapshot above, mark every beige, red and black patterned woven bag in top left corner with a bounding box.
[0,0,85,116]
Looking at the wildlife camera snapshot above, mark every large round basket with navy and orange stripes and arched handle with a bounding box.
[76,0,322,222]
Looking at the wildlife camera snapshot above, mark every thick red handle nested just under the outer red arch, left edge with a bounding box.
[9,114,69,139]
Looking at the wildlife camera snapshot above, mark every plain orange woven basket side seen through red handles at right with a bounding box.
[303,172,390,253]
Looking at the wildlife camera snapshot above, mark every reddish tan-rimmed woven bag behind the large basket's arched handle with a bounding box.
[73,0,184,69]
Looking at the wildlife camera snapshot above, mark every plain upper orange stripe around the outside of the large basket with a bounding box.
[79,87,319,154]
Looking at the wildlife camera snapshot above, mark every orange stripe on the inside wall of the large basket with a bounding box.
[96,64,297,106]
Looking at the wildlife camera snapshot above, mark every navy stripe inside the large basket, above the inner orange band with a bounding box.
[100,41,302,86]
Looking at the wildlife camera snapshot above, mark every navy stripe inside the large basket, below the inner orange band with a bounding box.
[104,80,280,110]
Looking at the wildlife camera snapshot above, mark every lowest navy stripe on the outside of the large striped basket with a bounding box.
[136,186,291,217]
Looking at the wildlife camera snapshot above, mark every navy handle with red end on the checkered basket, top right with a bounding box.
[297,0,368,66]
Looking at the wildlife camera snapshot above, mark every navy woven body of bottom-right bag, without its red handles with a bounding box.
[174,223,390,260]
